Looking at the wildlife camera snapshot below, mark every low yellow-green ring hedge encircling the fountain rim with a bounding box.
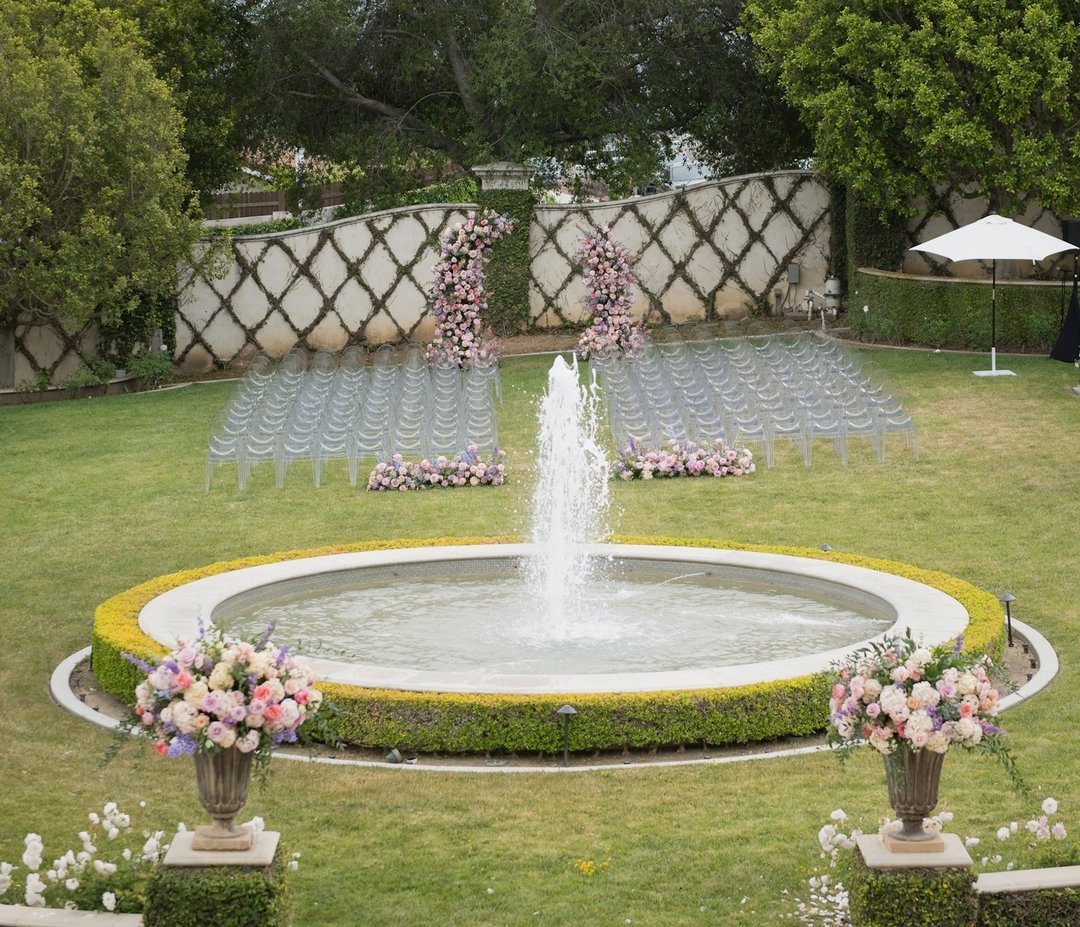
[92,537,1003,753]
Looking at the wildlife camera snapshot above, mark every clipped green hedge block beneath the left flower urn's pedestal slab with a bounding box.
[143,845,291,927]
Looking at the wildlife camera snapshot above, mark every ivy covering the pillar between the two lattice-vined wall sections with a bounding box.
[477,190,537,335]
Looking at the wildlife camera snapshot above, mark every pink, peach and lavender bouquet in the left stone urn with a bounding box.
[130,626,323,761]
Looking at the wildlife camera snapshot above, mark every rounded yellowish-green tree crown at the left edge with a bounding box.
[0,0,200,339]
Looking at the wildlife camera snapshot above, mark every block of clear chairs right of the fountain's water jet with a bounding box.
[590,326,918,467]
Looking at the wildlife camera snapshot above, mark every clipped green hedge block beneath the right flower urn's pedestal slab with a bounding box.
[837,854,978,927]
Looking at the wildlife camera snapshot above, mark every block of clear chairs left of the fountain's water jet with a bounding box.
[206,344,501,489]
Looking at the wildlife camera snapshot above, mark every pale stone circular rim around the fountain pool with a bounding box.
[138,543,969,695]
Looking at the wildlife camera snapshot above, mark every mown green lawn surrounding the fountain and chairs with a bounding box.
[0,350,1080,927]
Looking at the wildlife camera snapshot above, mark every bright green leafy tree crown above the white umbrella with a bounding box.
[746,0,1080,213]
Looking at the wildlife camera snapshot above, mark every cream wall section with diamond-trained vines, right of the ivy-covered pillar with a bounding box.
[529,171,831,326]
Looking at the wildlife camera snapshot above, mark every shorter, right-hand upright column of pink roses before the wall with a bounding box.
[576,226,643,361]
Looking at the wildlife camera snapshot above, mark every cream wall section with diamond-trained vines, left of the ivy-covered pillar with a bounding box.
[176,205,470,368]
